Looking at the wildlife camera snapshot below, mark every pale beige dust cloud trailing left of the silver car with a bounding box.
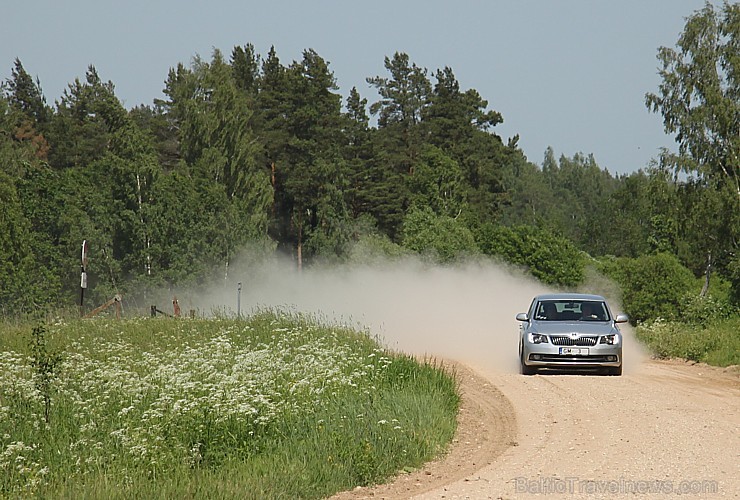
[192,254,548,372]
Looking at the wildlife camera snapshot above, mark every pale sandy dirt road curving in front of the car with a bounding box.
[337,360,740,499]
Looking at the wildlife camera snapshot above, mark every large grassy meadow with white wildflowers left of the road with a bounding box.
[0,311,459,498]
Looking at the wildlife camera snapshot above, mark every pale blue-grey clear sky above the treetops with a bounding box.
[0,0,708,173]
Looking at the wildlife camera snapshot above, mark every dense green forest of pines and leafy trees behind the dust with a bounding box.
[0,4,740,320]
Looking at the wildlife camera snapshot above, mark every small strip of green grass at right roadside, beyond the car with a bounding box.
[636,316,740,366]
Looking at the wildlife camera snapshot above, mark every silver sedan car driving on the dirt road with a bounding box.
[516,293,629,375]
